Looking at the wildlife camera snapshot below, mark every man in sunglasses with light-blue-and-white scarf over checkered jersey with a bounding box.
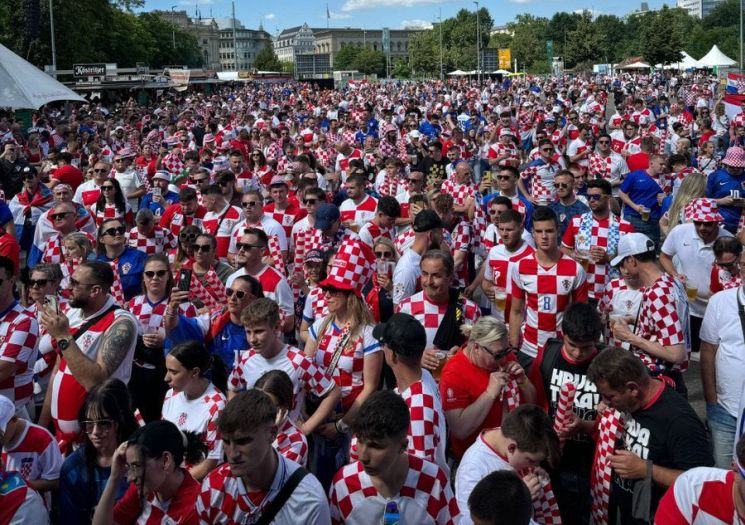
[561,180,634,306]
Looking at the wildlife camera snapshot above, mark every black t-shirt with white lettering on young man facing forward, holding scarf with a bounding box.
[531,339,600,477]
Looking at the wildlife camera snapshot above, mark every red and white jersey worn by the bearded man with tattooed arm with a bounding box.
[51,296,137,434]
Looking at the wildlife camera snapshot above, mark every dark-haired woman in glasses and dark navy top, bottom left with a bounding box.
[57,379,137,523]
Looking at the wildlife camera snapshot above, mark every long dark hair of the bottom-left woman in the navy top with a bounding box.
[78,378,137,508]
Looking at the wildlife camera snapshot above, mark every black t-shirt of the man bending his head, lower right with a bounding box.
[608,386,714,525]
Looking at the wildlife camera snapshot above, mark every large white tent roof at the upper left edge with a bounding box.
[0,44,85,109]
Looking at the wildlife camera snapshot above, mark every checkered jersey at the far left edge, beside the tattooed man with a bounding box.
[0,301,39,408]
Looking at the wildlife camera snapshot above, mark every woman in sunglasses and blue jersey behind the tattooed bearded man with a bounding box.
[96,217,147,305]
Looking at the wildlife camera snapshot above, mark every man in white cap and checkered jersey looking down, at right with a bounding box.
[611,233,690,395]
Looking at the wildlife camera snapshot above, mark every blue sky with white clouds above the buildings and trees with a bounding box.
[137,0,675,34]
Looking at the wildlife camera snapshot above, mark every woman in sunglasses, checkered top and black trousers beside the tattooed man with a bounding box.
[127,254,197,422]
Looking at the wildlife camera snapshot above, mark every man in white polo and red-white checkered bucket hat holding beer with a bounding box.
[660,199,732,358]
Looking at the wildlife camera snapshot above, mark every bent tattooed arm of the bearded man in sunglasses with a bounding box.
[64,318,137,390]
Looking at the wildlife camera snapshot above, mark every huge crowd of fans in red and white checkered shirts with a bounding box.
[0,72,745,525]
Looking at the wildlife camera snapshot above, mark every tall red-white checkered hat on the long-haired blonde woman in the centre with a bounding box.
[320,239,375,297]
